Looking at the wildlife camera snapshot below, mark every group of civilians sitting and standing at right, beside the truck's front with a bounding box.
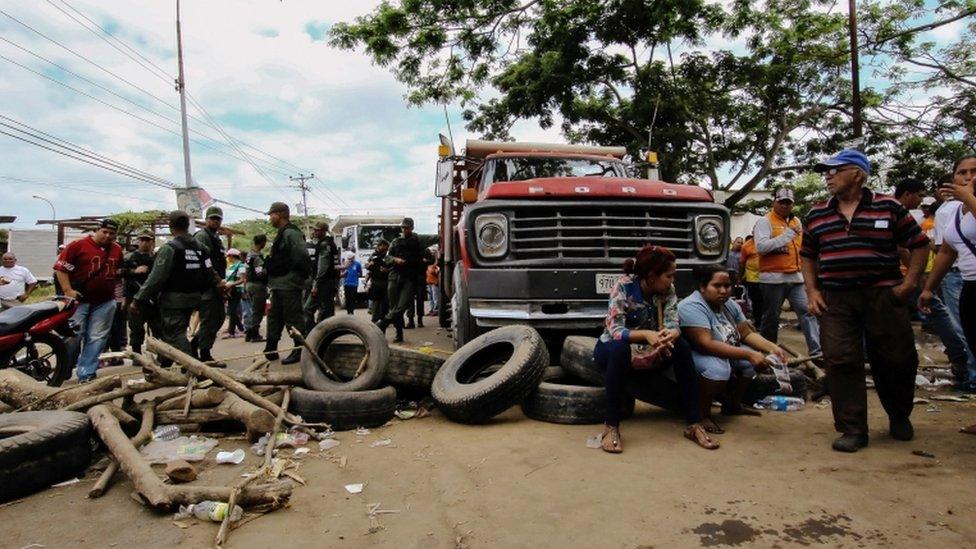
[593,149,976,453]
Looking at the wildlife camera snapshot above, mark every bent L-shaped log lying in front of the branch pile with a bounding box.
[88,405,292,510]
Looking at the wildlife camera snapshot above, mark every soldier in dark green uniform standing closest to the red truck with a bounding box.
[378,217,423,343]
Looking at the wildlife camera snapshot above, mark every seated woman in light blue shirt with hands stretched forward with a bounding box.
[678,265,787,434]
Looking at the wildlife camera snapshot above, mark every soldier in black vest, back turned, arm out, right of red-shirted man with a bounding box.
[129,210,215,366]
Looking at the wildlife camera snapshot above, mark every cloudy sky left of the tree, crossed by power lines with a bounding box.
[0,0,520,232]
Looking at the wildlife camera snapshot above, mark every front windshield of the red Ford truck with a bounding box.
[485,157,626,183]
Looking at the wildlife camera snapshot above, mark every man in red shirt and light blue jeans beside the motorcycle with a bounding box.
[54,219,122,383]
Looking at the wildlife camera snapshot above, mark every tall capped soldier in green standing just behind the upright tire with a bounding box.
[264,202,312,364]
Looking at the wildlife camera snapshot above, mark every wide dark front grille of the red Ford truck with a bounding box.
[509,205,695,260]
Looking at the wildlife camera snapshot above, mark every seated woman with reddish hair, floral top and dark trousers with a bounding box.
[593,246,718,454]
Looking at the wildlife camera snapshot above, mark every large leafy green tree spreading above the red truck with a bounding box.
[331,0,856,204]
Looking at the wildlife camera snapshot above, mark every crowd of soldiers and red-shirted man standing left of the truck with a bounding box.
[36,202,439,383]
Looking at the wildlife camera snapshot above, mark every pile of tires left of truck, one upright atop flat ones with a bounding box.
[288,315,443,431]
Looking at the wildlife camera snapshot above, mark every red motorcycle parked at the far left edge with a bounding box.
[0,296,81,387]
